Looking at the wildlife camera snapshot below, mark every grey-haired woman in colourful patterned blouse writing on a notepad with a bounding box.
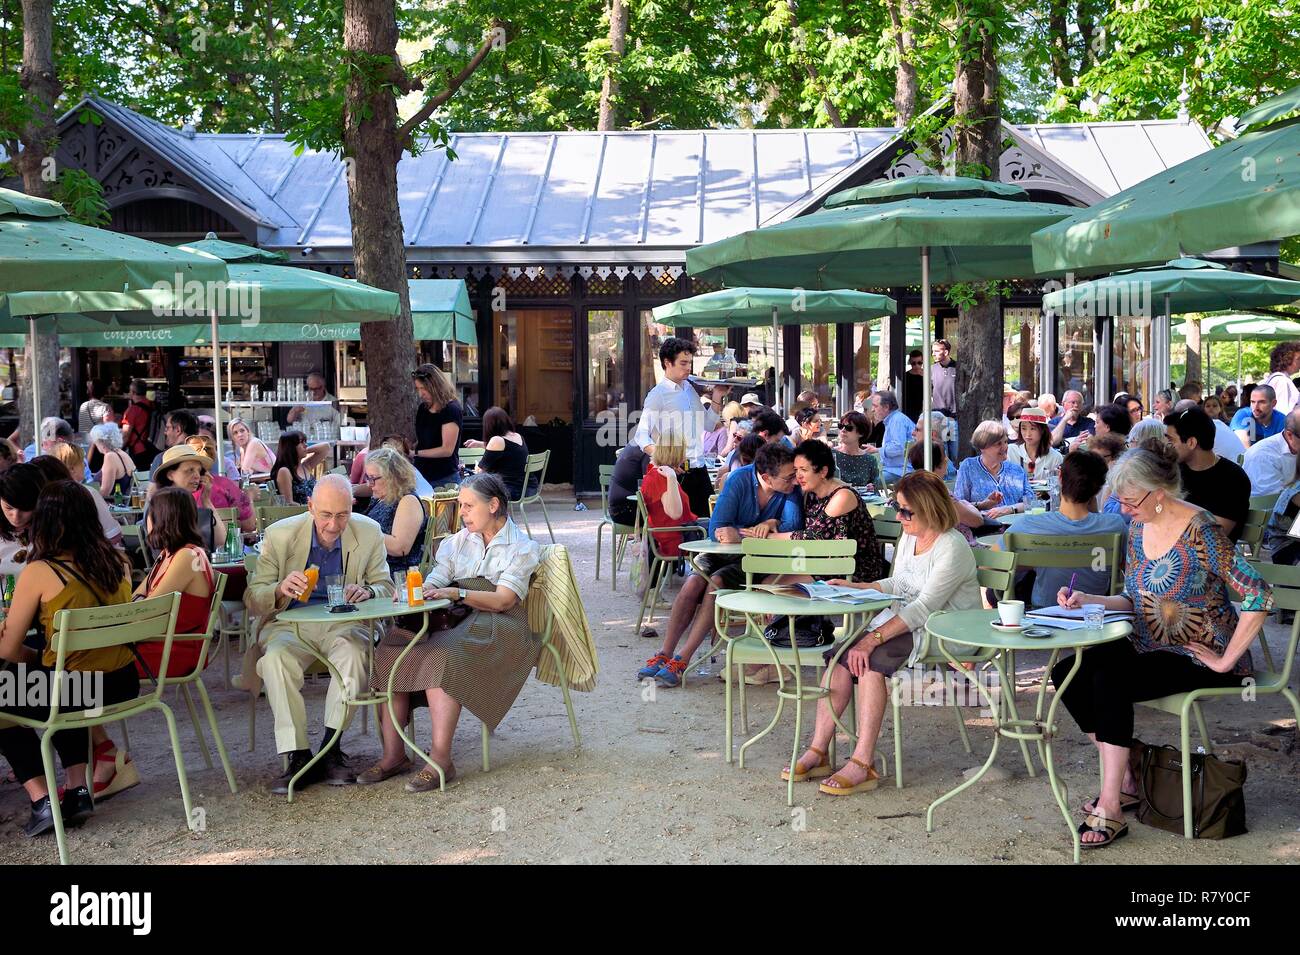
[1052,442,1273,848]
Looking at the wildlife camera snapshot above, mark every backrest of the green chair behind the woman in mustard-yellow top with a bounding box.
[49,594,181,719]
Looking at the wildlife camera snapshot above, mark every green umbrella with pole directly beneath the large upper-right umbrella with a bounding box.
[1043,259,1300,392]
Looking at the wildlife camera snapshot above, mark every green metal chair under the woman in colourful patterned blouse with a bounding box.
[1140,561,1300,839]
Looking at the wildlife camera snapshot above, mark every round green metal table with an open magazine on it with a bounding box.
[718,590,893,806]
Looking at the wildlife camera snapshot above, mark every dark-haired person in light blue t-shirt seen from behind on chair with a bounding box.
[1011,451,1128,607]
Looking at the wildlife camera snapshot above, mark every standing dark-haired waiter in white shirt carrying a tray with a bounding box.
[633,338,714,515]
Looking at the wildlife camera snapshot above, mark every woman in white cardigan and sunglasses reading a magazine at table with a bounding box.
[781,467,977,795]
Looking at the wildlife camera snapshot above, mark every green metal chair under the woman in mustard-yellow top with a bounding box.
[4,594,195,865]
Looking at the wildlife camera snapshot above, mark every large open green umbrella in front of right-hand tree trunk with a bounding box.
[686,177,1075,465]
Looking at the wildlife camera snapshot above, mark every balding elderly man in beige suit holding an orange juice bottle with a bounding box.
[244,474,393,794]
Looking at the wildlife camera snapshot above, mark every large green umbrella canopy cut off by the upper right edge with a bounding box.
[1032,123,1300,274]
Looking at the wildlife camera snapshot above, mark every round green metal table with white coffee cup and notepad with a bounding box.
[926,611,1132,861]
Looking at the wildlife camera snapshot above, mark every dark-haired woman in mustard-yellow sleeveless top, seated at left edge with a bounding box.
[0,481,140,835]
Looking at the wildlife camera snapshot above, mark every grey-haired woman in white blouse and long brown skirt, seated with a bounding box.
[356,470,542,793]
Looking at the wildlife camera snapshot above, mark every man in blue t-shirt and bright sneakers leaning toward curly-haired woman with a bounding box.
[637,442,803,686]
